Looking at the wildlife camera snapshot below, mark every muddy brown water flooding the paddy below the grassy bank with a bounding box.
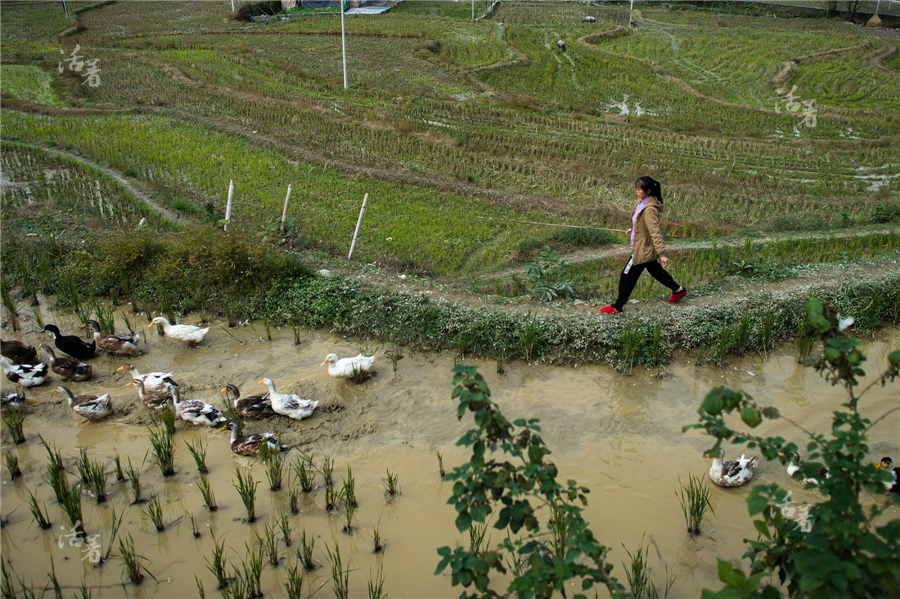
[0,308,900,598]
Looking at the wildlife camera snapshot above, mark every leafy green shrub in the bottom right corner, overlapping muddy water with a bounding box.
[685,298,900,599]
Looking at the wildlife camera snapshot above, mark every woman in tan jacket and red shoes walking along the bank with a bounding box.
[600,177,687,314]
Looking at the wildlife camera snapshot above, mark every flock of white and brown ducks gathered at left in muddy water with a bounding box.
[0,317,375,455]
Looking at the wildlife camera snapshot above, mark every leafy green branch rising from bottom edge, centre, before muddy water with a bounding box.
[436,365,624,599]
